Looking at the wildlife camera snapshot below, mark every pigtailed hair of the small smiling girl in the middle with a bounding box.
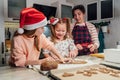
[50,18,72,43]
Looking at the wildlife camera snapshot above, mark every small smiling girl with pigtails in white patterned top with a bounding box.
[43,18,78,59]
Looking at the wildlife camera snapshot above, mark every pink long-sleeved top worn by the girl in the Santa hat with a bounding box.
[10,34,53,66]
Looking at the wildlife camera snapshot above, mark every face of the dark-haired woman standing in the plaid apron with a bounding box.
[74,9,85,23]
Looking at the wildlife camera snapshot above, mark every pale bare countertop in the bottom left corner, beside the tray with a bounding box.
[0,66,50,80]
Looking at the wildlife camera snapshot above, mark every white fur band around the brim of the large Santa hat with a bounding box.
[24,18,47,30]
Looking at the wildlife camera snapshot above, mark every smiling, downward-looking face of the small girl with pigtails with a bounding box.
[55,23,67,40]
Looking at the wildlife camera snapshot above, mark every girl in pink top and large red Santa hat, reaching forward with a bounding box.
[9,8,64,67]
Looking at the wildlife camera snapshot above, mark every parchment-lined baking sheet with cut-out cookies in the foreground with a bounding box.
[51,64,120,80]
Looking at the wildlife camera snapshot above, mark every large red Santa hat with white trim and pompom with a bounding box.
[18,8,47,34]
